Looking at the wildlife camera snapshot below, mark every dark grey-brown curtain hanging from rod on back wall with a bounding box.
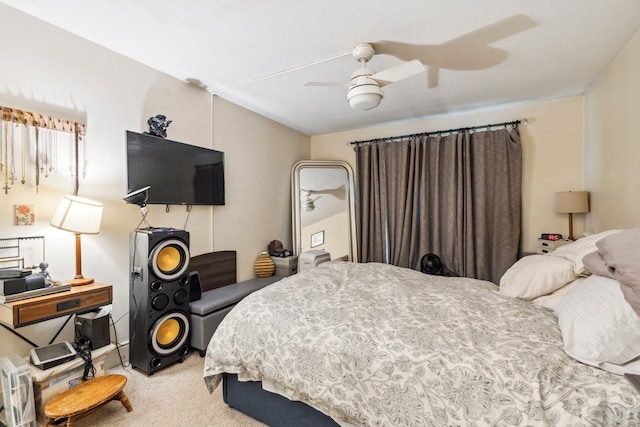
[356,127,522,283]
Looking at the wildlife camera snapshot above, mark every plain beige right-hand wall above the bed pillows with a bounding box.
[584,29,640,231]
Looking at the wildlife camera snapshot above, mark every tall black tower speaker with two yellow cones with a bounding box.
[129,228,190,375]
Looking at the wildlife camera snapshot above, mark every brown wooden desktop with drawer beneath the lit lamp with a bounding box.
[0,283,113,328]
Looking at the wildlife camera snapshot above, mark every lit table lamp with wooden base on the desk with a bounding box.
[49,196,102,286]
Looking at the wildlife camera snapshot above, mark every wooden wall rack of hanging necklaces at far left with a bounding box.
[0,106,87,195]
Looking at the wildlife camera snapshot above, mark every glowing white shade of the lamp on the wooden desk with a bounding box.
[49,196,102,234]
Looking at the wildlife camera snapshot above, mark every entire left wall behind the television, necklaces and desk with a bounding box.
[0,4,309,355]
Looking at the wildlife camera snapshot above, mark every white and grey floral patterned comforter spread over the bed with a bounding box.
[204,262,640,426]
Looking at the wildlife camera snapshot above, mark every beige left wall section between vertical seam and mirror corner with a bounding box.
[213,97,310,280]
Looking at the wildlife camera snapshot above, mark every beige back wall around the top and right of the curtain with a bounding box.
[311,97,584,252]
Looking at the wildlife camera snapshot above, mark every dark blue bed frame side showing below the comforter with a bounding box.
[222,373,338,427]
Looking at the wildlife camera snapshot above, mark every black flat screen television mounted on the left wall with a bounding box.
[127,131,225,205]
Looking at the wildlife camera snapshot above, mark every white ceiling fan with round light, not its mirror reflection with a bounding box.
[305,43,425,111]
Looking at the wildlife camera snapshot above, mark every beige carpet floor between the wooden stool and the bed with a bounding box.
[69,353,265,427]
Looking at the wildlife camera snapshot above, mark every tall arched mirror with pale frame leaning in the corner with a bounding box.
[291,160,358,262]
